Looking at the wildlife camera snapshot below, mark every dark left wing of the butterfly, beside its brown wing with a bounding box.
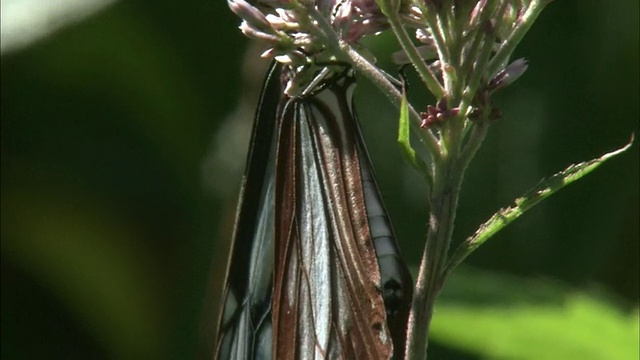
[215,62,283,359]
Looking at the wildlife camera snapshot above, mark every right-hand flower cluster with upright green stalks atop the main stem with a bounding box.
[393,0,532,128]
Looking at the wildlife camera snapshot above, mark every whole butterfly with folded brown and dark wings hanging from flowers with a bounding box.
[215,62,413,359]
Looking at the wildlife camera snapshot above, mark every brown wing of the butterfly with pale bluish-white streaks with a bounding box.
[273,71,410,359]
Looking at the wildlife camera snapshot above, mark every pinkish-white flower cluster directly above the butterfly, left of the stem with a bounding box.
[228,0,386,67]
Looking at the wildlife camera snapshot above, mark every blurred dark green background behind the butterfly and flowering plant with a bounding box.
[1,0,639,359]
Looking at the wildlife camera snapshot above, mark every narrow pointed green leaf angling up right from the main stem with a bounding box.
[444,137,633,276]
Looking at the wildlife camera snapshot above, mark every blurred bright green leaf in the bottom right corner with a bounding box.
[430,269,639,360]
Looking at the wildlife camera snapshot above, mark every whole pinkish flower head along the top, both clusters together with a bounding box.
[228,0,551,123]
